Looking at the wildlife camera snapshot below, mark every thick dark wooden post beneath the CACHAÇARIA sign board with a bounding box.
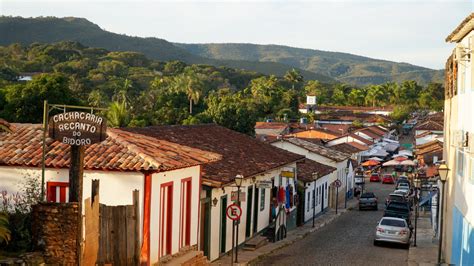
[69,145,85,265]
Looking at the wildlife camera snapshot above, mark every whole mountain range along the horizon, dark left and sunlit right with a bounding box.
[0,16,443,85]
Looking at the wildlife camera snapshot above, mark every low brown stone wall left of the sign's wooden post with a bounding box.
[32,203,78,265]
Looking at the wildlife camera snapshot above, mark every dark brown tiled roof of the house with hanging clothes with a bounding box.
[122,124,305,186]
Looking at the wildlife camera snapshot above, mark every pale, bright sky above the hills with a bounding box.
[0,0,474,69]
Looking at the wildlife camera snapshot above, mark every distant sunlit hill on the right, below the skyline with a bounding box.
[176,43,443,85]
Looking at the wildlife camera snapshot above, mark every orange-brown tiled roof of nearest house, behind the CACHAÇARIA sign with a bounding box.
[0,124,220,171]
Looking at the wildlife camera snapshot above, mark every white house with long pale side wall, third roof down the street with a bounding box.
[271,138,350,209]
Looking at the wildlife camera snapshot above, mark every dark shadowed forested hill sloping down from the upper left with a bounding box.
[0,16,334,82]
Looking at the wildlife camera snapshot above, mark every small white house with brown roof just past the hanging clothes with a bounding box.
[297,159,336,222]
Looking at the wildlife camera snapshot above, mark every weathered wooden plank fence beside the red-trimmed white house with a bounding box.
[83,180,140,265]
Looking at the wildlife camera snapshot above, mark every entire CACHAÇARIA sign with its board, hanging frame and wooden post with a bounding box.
[46,106,107,265]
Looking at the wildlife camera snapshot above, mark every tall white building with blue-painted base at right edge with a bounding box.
[440,13,474,265]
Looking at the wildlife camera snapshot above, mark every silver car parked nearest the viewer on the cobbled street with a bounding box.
[374,217,411,248]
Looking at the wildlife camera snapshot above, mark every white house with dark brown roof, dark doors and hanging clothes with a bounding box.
[123,124,304,261]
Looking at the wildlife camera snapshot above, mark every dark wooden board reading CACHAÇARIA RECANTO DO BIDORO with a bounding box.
[49,111,107,146]
